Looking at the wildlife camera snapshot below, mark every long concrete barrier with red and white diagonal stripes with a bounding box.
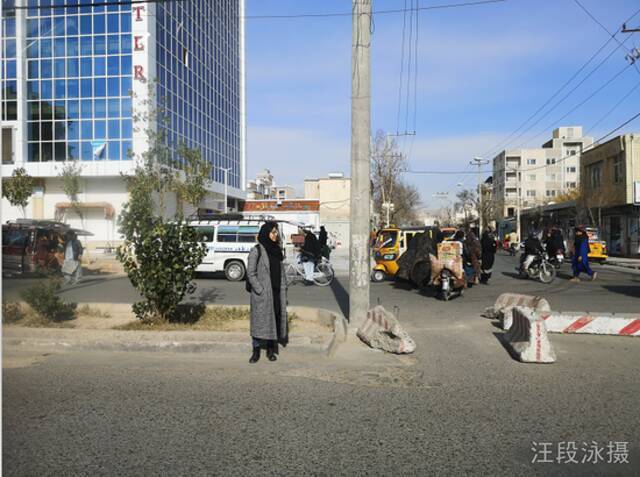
[541,311,640,337]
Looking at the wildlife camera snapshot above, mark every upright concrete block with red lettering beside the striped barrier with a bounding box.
[503,307,556,363]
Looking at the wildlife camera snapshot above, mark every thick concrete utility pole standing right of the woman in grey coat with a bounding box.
[349,0,371,327]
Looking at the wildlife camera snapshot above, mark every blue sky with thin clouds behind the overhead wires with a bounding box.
[246,0,640,208]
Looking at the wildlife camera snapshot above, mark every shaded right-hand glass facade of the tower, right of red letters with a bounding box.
[156,0,241,188]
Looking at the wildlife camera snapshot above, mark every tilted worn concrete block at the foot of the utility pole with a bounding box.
[356,306,416,354]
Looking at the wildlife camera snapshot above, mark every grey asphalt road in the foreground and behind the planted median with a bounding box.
[3,251,640,475]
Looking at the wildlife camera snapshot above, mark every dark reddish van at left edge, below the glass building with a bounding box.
[2,219,93,276]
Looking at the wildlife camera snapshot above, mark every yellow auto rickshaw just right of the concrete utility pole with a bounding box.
[371,227,435,282]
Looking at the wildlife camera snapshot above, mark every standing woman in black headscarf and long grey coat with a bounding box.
[247,221,289,363]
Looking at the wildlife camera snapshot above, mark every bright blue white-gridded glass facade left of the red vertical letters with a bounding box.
[22,0,133,162]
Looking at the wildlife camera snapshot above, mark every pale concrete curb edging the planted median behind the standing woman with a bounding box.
[3,303,346,356]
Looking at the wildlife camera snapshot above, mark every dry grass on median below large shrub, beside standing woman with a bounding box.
[114,307,297,332]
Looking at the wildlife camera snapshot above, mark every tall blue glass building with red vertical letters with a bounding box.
[1,0,245,241]
